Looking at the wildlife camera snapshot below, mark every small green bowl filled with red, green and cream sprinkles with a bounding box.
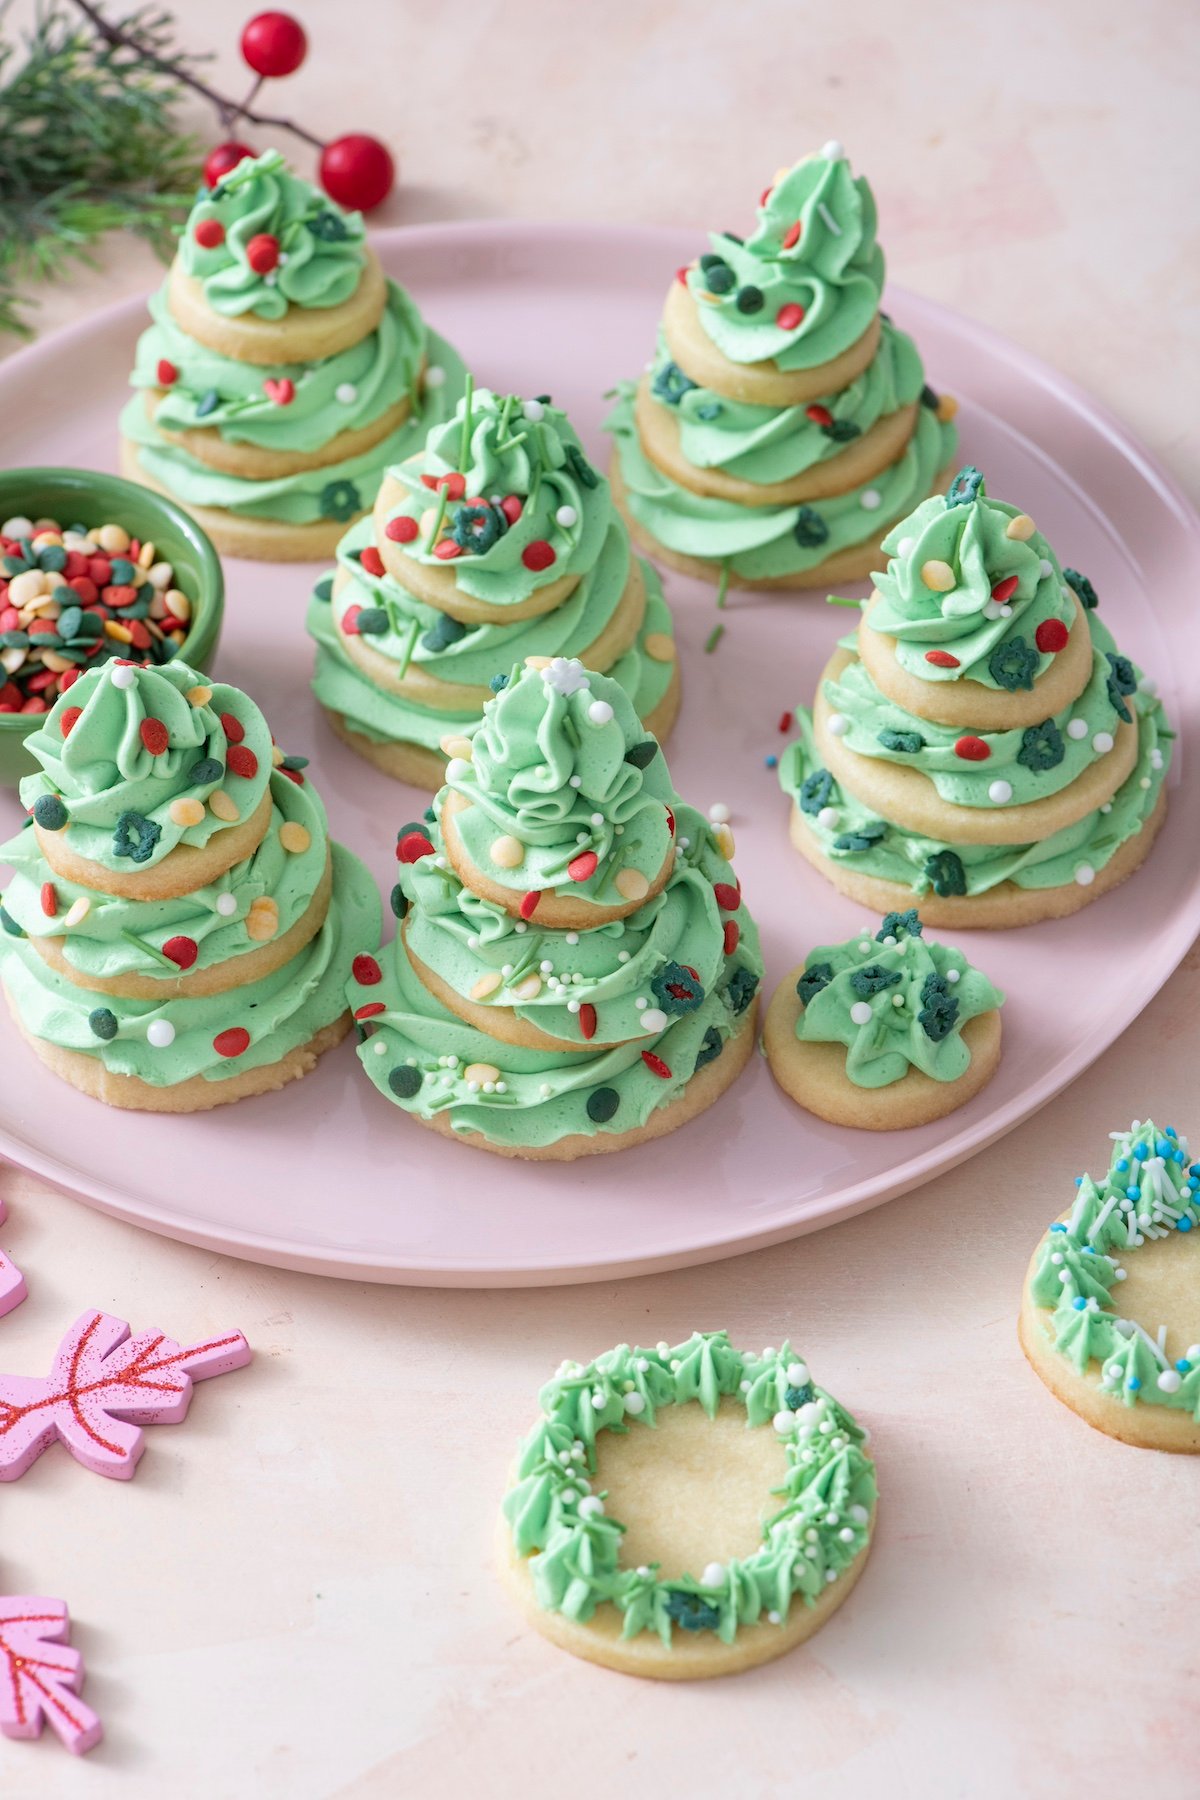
[0,468,225,787]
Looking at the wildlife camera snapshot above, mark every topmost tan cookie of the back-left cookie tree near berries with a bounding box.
[167,250,387,367]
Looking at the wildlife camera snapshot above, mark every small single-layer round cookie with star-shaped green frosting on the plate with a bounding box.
[763,909,1004,1130]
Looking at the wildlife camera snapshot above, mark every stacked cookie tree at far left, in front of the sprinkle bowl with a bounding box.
[0,662,380,1112]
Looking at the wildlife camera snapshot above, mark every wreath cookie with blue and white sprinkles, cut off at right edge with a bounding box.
[1018,1120,1200,1454]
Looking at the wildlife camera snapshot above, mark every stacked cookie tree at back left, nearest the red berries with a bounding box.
[121,149,464,562]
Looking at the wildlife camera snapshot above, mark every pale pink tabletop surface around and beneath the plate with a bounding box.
[0,0,1200,1800]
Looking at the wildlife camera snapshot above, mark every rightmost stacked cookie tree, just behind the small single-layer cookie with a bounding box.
[779,468,1171,927]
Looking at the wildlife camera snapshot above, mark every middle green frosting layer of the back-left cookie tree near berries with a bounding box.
[130,281,428,454]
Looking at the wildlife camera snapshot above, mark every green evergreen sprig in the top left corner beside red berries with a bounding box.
[0,0,201,337]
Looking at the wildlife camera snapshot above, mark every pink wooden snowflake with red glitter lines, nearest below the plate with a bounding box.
[0,1312,250,1481]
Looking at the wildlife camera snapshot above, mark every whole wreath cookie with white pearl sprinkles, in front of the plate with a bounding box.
[500,1332,876,1681]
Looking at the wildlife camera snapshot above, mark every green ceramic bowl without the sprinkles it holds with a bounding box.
[0,468,225,787]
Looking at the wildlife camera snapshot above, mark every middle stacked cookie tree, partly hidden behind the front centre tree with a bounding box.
[308,389,678,788]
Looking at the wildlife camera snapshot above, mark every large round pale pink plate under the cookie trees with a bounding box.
[0,223,1200,1287]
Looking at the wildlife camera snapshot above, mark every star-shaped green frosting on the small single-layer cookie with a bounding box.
[795,911,1004,1087]
